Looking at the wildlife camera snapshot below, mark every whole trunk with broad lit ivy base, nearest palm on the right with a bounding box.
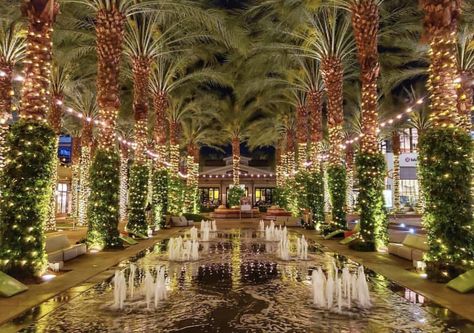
[419,0,474,280]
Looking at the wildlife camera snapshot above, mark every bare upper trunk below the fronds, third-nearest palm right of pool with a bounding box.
[321,57,344,166]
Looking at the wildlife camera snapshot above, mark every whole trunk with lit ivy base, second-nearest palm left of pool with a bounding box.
[87,1,125,249]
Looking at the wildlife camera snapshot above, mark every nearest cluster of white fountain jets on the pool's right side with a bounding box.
[311,266,371,312]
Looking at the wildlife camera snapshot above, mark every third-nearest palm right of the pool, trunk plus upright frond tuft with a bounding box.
[303,7,354,227]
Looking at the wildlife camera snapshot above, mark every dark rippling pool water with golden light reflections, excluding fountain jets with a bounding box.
[5,229,472,333]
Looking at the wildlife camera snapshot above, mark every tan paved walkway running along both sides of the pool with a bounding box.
[0,219,474,326]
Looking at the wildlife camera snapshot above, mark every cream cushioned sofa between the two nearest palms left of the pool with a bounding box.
[45,235,87,263]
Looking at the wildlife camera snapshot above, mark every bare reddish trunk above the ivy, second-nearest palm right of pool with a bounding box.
[351,0,380,154]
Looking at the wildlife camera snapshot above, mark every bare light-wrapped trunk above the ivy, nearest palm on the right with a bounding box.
[420,0,461,127]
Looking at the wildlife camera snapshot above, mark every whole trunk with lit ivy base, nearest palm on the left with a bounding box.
[0,0,59,278]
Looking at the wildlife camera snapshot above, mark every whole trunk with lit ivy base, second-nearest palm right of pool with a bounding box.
[350,0,388,249]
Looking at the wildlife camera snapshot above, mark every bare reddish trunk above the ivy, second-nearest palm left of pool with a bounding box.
[95,7,125,149]
